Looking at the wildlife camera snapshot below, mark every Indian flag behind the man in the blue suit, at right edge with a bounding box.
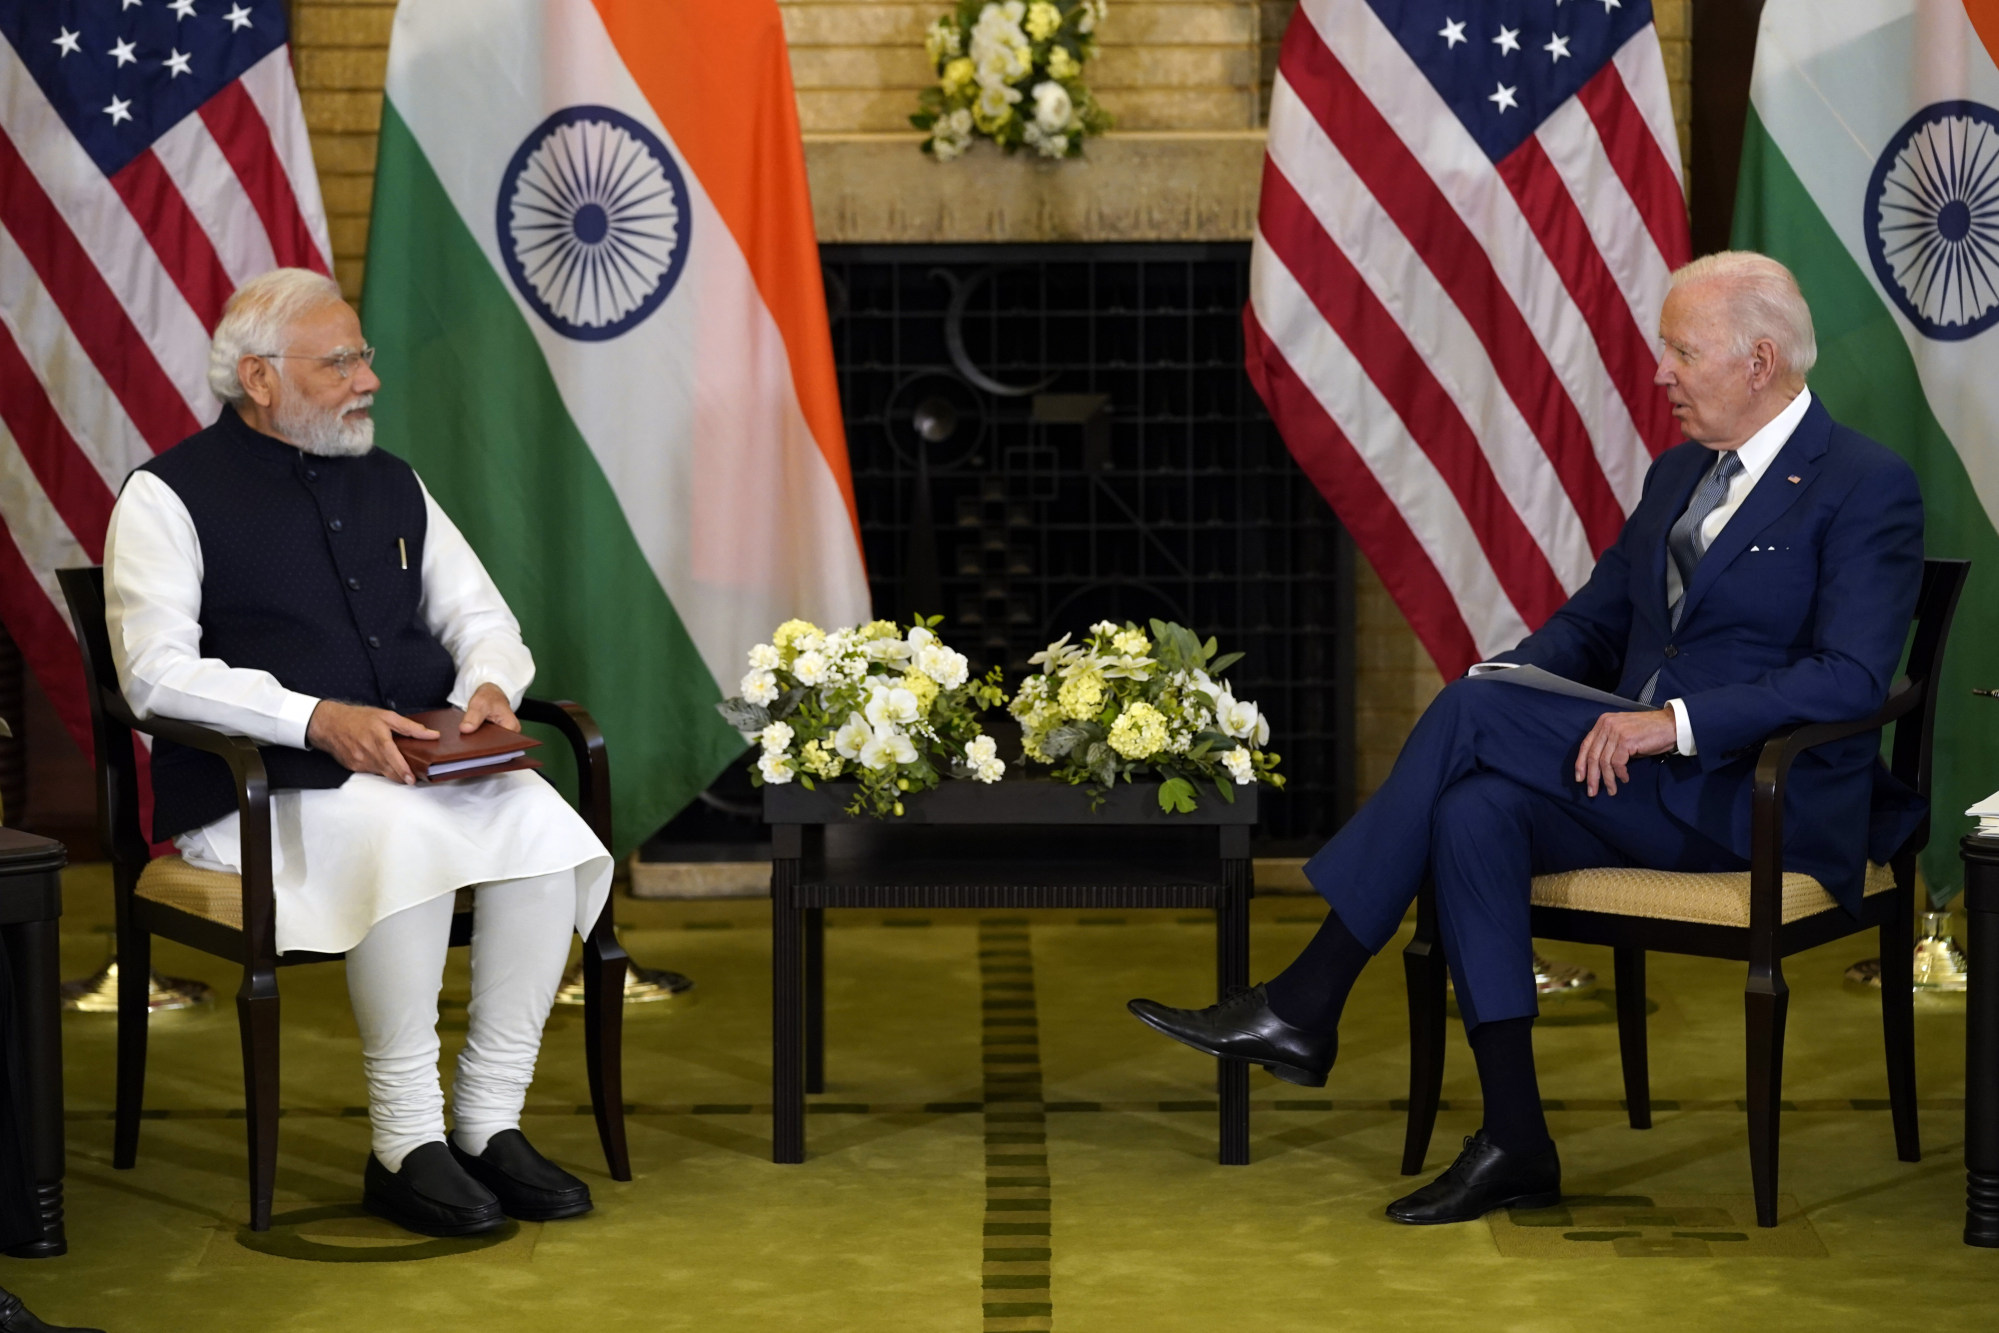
[1735,0,1999,901]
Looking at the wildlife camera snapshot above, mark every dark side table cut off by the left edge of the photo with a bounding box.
[0,827,70,1259]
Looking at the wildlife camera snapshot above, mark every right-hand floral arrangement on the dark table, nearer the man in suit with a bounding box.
[1007,620,1283,813]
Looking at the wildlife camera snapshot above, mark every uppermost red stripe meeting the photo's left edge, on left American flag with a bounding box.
[0,134,200,452]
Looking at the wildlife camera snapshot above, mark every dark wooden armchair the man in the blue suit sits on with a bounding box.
[1401,560,1971,1227]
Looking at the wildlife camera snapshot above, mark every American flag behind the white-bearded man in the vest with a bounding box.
[0,0,332,767]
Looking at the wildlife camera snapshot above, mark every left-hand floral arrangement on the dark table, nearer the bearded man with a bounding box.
[716,616,1005,817]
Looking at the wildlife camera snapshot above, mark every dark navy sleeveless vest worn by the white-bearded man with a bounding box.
[144,408,456,841]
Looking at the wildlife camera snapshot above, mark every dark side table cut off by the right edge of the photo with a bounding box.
[1959,837,1999,1249]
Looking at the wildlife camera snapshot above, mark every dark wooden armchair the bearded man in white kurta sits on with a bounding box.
[56,568,632,1231]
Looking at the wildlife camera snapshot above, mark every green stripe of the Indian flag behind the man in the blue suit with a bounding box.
[1733,108,1999,899]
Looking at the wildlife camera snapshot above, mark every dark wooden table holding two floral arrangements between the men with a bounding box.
[764,779,1255,1165]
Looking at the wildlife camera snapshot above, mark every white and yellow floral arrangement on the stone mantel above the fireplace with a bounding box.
[910,0,1111,162]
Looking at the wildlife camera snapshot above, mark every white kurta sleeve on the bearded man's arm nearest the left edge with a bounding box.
[104,472,320,749]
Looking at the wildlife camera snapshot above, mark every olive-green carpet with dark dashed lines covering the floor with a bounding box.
[0,865,1999,1333]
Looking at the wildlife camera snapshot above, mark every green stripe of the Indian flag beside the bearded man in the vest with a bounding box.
[364,102,744,855]
